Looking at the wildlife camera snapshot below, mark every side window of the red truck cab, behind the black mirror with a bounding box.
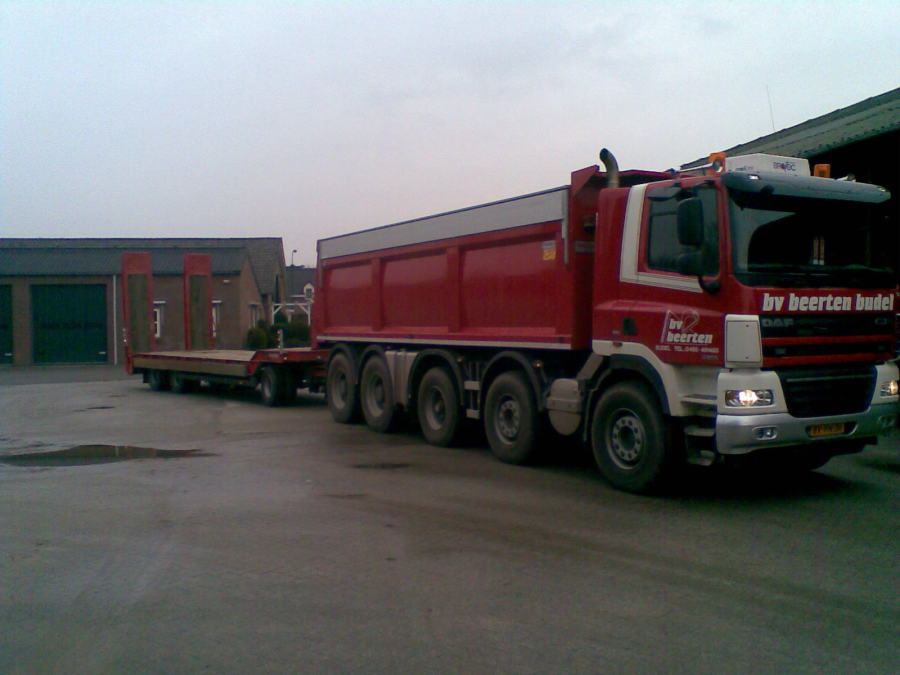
[647,187,719,275]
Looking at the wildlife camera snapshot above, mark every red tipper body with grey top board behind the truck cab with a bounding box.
[313,167,664,350]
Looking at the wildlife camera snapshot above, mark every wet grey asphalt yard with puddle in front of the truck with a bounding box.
[0,369,900,673]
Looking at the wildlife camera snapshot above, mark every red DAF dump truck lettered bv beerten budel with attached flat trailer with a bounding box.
[133,150,900,492]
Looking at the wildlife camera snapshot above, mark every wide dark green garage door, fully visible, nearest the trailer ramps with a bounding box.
[31,284,107,363]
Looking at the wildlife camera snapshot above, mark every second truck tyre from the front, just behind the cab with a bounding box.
[484,372,538,464]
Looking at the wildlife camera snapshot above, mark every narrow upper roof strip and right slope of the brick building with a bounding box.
[0,237,284,295]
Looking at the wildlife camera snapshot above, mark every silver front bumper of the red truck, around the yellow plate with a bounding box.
[716,402,900,455]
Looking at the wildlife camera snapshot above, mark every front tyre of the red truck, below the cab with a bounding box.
[591,382,673,493]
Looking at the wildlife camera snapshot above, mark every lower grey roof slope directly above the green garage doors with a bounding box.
[0,244,249,276]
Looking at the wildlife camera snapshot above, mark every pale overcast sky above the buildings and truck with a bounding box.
[0,0,900,265]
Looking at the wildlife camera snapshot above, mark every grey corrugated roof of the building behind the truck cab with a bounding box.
[681,87,900,169]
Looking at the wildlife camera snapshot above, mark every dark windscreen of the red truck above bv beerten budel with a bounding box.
[729,190,898,288]
